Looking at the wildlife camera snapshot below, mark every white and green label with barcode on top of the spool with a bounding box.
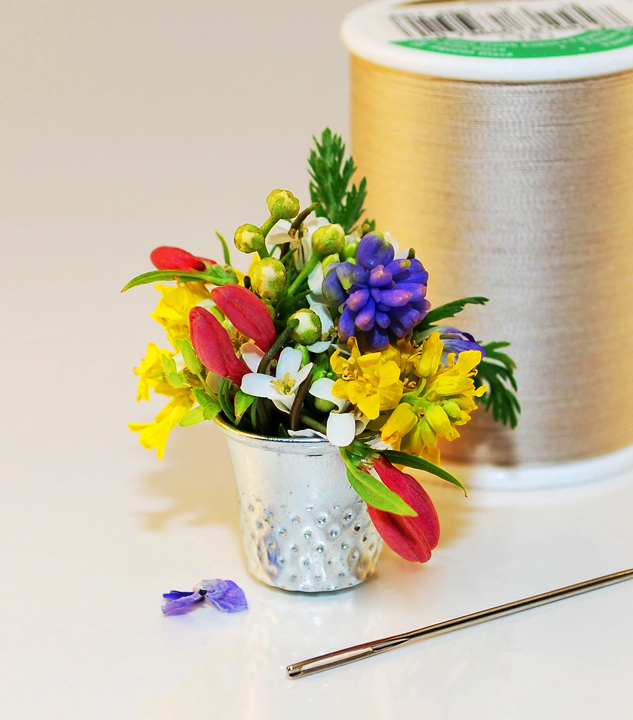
[389,0,633,59]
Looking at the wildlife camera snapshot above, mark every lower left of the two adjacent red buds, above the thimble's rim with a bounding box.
[189,307,250,385]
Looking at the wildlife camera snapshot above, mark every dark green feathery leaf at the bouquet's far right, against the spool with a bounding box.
[475,342,521,428]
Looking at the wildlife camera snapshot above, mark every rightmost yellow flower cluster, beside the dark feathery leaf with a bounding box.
[381,332,485,462]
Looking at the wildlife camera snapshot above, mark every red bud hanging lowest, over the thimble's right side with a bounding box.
[367,455,440,562]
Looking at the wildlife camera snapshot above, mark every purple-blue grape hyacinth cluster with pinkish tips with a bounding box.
[322,232,430,352]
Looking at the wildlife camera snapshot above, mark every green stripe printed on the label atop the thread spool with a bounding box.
[393,27,633,58]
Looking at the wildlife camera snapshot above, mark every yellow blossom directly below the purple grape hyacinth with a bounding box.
[330,338,404,420]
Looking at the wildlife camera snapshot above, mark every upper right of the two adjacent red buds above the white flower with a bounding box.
[211,285,277,352]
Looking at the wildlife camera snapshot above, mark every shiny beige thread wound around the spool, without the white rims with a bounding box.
[352,55,633,465]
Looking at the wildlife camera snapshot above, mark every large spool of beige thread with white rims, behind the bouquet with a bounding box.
[342,0,633,488]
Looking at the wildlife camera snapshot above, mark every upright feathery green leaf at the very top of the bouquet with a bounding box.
[308,128,367,234]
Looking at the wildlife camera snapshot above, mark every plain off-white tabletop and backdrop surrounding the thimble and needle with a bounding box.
[0,0,633,720]
